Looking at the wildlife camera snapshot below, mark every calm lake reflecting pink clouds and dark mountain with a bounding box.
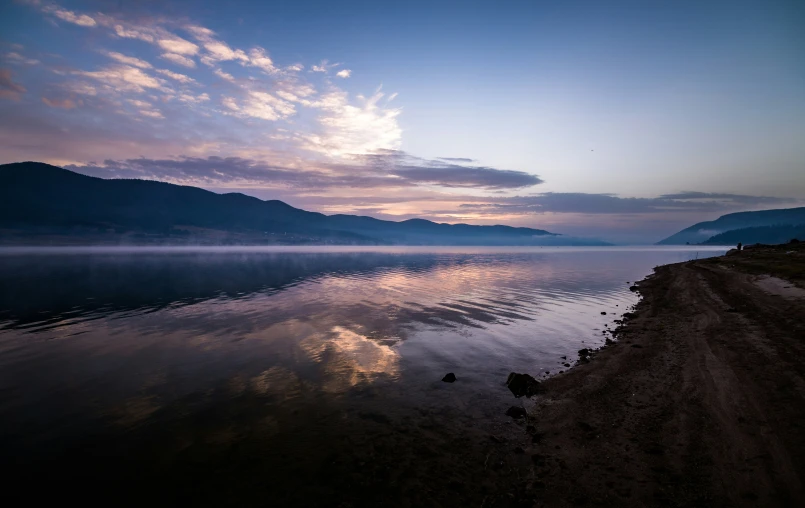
[0,246,725,506]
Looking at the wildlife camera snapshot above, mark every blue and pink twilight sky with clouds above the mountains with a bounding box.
[0,0,805,243]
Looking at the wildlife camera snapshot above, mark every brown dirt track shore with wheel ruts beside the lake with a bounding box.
[528,258,805,506]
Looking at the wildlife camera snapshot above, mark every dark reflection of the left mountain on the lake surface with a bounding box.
[0,253,446,326]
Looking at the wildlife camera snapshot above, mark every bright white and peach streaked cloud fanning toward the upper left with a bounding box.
[18,0,402,157]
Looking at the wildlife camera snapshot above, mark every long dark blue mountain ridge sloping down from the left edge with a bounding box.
[0,162,604,245]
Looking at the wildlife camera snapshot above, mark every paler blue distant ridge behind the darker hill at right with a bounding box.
[657,207,805,245]
